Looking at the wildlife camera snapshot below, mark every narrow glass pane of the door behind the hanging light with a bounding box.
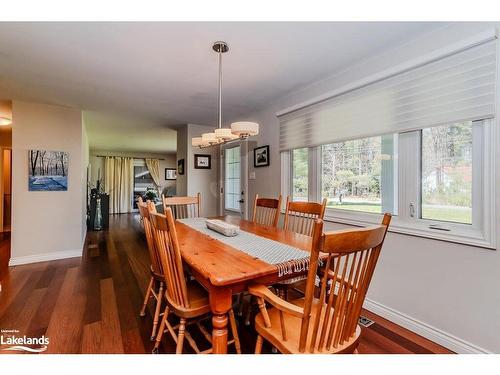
[224,146,241,212]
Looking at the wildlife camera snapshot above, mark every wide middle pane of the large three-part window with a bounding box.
[321,135,397,213]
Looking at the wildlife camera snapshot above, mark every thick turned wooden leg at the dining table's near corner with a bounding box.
[209,287,232,354]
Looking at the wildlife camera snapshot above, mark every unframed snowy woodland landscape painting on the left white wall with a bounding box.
[28,150,69,191]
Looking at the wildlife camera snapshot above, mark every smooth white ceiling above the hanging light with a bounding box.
[0,22,447,152]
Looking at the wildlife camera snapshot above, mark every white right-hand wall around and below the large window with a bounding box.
[246,23,500,353]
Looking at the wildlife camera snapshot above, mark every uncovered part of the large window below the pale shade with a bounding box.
[282,120,495,248]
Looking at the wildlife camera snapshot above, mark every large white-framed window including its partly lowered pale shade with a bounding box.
[276,37,499,248]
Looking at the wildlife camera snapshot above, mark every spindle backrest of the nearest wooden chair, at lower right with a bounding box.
[299,214,391,353]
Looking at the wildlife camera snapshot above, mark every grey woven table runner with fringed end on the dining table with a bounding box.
[178,217,309,278]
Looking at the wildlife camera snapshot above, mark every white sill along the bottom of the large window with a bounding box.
[324,209,496,250]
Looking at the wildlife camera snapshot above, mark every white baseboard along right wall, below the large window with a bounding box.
[363,298,492,354]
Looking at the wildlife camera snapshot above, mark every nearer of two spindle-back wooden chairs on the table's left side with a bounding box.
[151,207,241,354]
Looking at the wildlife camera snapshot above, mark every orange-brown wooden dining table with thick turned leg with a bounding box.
[176,216,312,354]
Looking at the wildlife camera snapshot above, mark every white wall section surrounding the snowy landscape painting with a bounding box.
[10,101,86,265]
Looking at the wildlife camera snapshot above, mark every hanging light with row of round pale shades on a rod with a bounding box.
[191,41,259,148]
